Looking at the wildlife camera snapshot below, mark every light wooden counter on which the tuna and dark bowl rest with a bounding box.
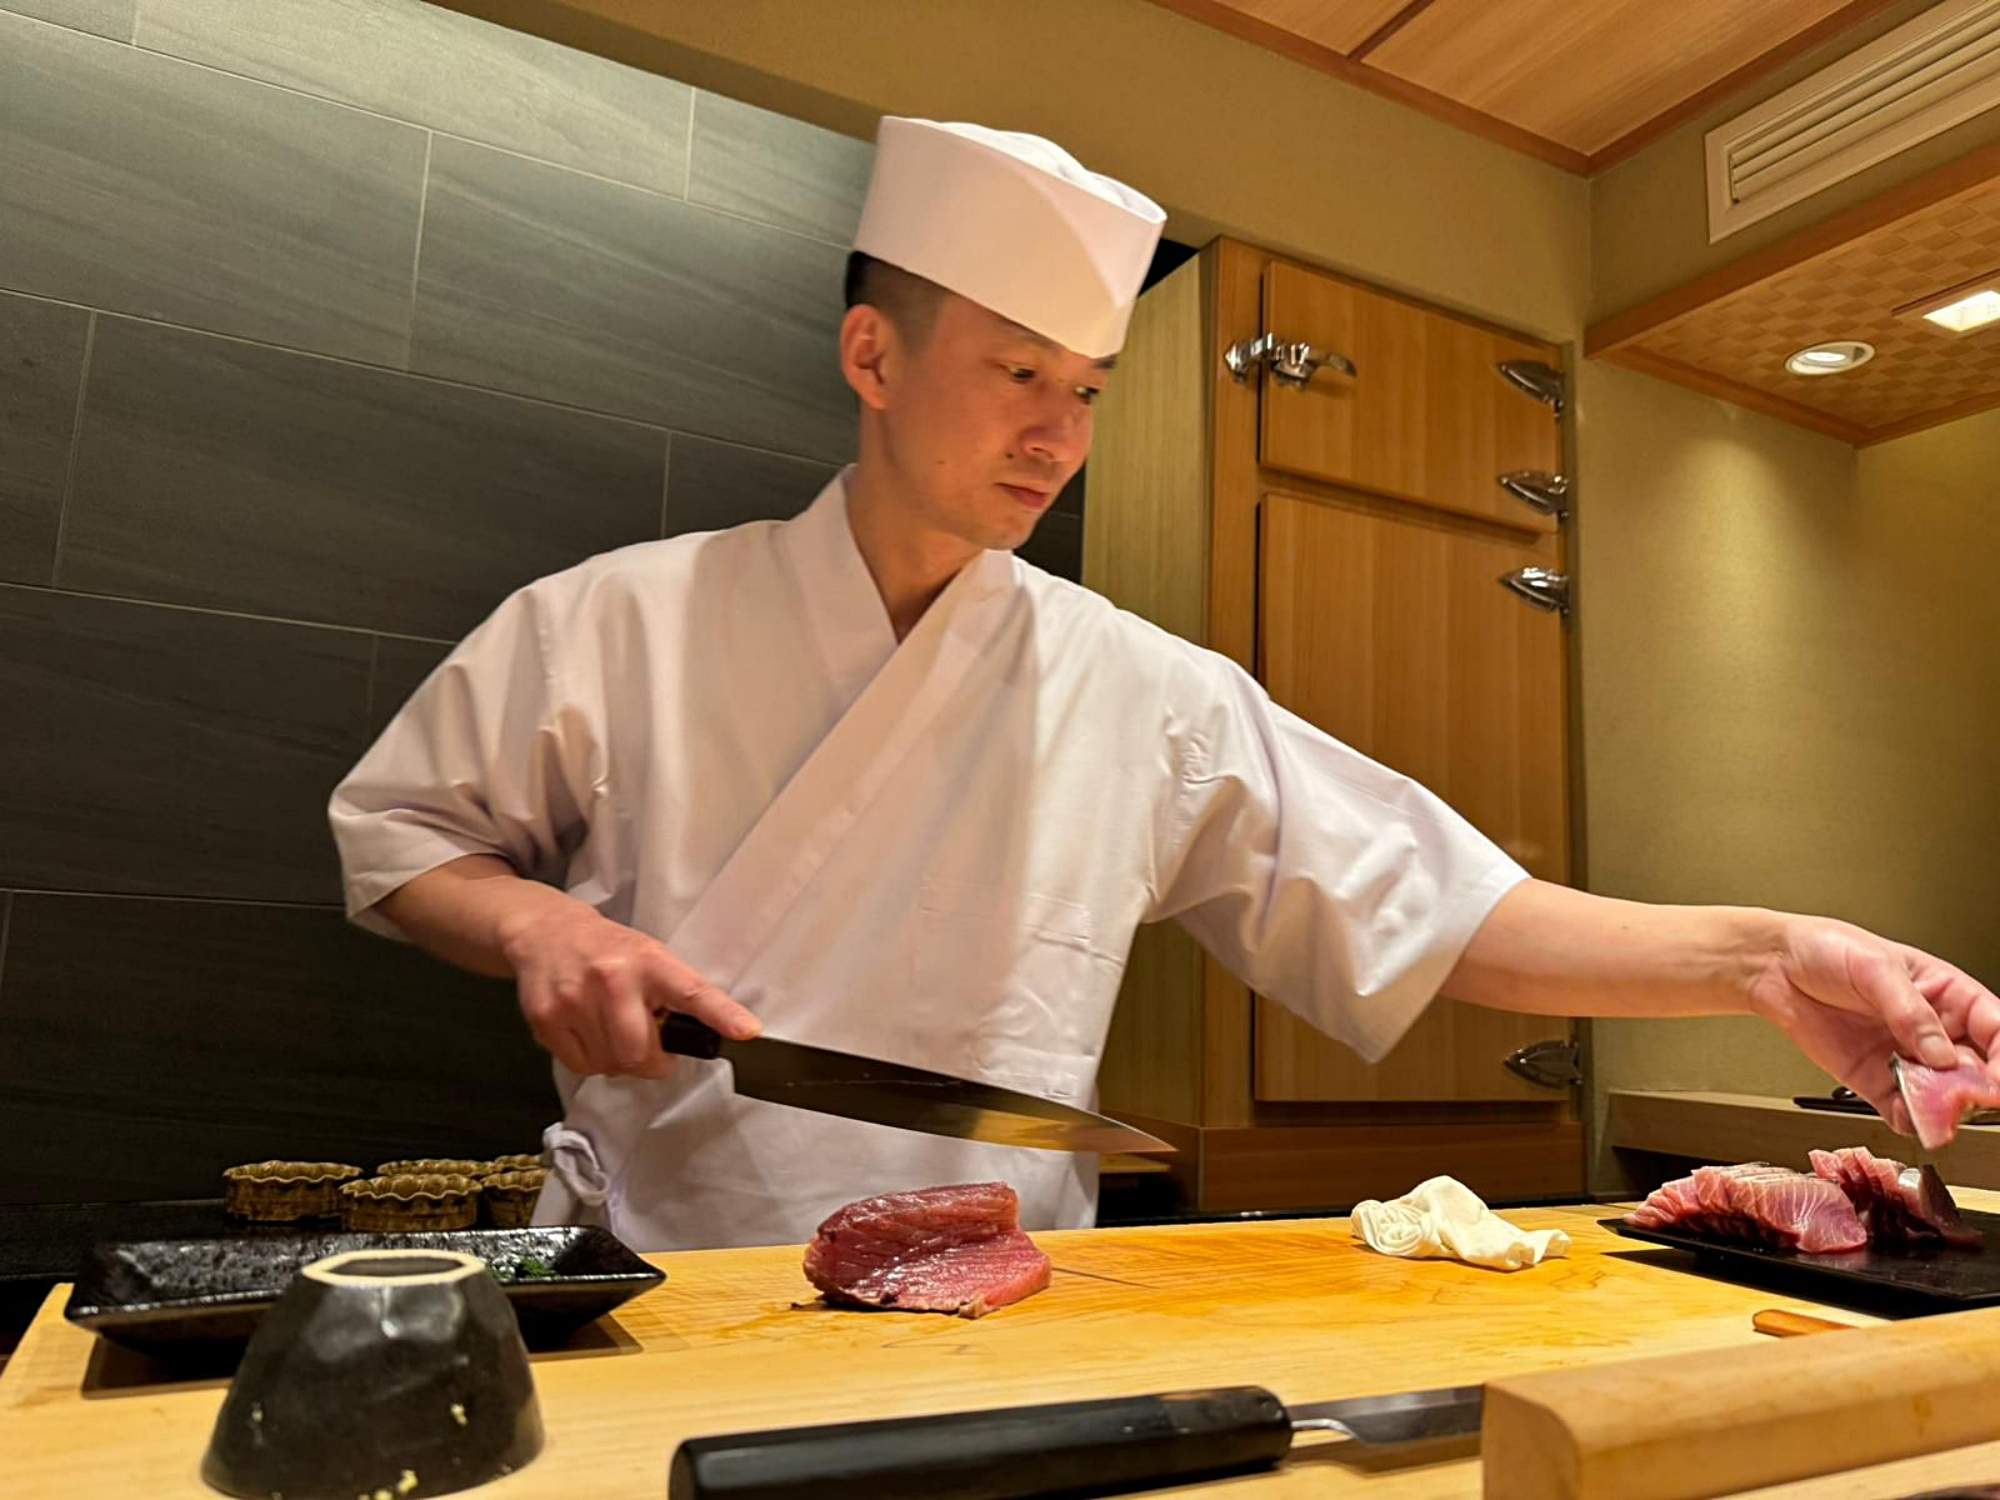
[11,1192,2000,1500]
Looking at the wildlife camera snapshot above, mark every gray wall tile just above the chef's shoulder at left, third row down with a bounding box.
[56,316,666,638]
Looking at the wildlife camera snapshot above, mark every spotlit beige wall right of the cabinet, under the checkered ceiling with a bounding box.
[1578,374,2000,1188]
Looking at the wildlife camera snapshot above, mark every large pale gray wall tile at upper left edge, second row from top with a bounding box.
[0,12,428,364]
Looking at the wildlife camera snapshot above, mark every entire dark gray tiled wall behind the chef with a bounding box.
[0,0,1032,1202]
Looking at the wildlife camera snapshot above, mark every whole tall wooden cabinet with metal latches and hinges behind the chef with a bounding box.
[1084,240,1582,1210]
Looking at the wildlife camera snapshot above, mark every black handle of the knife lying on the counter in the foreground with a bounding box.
[666,1386,1292,1500]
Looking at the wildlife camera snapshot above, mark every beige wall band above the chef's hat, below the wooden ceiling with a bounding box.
[450,0,1590,342]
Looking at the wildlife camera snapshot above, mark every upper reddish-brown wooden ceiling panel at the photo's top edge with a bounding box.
[1156,0,1890,172]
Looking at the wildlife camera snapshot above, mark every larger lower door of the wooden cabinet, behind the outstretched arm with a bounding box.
[1254,492,1568,1100]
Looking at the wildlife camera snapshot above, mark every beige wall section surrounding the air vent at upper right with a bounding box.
[1590,0,2000,322]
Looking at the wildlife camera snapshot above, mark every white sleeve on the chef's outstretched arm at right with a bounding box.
[1148,652,1528,1062]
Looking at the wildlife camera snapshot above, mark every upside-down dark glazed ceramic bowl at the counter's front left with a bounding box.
[202,1250,542,1500]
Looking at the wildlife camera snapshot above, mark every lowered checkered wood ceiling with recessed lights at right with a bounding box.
[1584,148,2000,444]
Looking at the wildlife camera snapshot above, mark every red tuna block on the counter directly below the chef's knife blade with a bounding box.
[806,1182,1048,1318]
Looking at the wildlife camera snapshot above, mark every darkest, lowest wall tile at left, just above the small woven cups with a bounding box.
[0,894,548,1202]
